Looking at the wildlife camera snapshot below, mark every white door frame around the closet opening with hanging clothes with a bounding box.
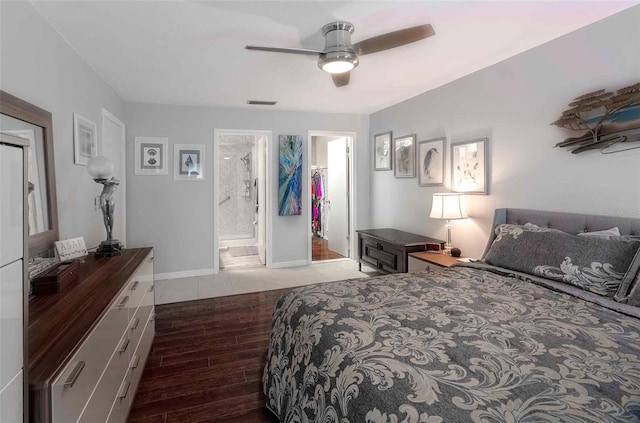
[305,130,358,264]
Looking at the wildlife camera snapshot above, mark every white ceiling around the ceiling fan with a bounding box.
[32,0,638,113]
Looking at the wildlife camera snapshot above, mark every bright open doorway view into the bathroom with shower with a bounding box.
[214,130,271,270]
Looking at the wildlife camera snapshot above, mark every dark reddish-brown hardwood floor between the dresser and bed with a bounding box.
[129,289,291,423]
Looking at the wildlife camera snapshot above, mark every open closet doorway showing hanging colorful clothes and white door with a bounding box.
[309,131,353,262]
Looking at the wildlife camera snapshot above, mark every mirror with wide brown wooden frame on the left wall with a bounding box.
[0,91,58,257]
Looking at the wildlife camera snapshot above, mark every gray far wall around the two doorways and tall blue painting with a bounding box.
[125,103,370,273]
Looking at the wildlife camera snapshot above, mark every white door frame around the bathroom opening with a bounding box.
[213,128,273,274]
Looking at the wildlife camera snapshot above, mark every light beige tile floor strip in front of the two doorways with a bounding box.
[156,259,377,304]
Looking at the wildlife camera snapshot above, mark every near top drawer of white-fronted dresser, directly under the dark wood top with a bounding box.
[51,292,129,423]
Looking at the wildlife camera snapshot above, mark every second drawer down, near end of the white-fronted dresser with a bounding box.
[79,333,135,423]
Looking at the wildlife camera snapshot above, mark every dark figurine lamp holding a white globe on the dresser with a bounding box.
[87,156,124,257]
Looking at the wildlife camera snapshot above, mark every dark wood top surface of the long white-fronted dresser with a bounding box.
[27,248,151,389]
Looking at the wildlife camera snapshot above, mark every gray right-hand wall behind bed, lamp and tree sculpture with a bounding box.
[370,6,640,257]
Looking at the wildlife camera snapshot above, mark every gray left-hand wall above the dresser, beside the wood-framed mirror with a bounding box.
[0,1,124,252]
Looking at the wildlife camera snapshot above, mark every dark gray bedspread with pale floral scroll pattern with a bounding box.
[263,267,640,423]
